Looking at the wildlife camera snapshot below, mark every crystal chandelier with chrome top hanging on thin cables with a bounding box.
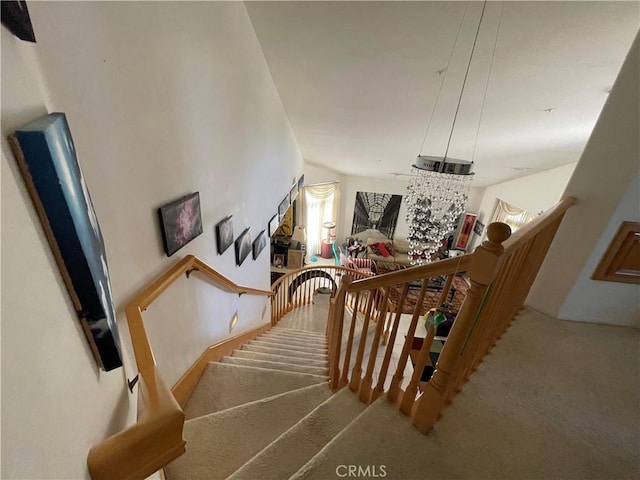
[405,0,502,265]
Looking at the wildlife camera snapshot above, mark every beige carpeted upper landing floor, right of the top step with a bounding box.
[293,311,640,480]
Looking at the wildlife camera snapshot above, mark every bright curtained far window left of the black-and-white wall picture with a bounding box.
[300,183,340,256]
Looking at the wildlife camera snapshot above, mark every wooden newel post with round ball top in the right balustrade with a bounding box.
[413,222,511,433]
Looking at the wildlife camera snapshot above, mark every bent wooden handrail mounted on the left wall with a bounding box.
[87,255,272,480]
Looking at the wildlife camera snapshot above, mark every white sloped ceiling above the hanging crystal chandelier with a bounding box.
[246,1,640,186]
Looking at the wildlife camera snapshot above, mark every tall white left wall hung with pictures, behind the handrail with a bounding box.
[2,2,303,479]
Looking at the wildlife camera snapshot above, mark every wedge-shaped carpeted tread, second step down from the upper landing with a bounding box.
[165,385,331,480]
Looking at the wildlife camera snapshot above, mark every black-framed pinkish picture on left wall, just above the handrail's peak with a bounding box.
[158,192,202,257]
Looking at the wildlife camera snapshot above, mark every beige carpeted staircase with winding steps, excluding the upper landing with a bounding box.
[166,326,366,480]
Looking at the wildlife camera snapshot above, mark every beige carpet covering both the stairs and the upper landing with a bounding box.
[167,310,640,480]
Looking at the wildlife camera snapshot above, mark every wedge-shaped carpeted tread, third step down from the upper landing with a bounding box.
[184,362,327,419]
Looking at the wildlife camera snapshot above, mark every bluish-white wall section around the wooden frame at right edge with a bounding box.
[558,176,640,328]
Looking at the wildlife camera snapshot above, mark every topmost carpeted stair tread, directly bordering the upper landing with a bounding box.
[229,388,366,480]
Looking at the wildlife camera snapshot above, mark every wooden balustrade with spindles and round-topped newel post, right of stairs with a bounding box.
[328,198,575,433]
